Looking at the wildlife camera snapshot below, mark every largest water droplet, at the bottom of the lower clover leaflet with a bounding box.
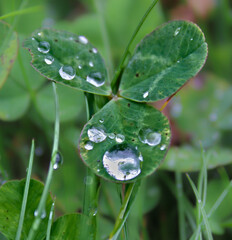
[103,144,141,181]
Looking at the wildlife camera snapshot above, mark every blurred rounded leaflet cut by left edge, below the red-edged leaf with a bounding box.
[0,78,30,121]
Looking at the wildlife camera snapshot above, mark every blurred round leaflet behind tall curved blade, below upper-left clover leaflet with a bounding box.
[36,84,84,122]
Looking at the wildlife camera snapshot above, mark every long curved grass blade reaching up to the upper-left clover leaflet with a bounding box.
[27,82,60,240]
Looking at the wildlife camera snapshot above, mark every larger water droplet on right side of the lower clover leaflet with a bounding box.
[139,128,161,147]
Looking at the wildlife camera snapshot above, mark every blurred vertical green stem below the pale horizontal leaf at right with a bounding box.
[175,172,186,240]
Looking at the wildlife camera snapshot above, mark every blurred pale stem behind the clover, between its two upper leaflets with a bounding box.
[94,0,113,79]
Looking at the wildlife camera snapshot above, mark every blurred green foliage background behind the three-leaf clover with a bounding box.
[0,0,232,240]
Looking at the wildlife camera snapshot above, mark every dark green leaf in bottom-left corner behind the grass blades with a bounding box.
[0,179,52,240]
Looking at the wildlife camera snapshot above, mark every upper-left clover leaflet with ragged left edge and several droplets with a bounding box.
[24,29,110,95]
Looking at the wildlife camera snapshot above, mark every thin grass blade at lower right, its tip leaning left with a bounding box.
[186,174,213,240]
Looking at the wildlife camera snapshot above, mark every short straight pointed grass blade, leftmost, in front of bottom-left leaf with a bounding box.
[15,140,35,240]
